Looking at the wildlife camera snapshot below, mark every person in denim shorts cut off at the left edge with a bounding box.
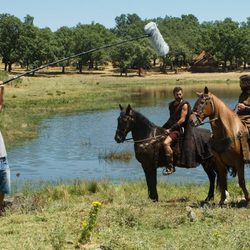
[0,81,10,215]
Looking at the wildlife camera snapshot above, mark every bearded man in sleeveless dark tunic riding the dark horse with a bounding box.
[163,87,190,175]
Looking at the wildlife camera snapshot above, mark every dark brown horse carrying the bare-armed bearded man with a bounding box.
[115,105,216,202]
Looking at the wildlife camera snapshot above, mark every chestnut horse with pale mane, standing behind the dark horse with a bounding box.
[190,87,250,204]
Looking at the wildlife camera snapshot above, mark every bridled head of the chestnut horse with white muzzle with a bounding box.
[190,87,214,127]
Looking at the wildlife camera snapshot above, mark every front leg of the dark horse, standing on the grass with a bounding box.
[142,164,158,202]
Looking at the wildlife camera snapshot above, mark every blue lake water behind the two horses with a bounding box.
[8,89,250,188]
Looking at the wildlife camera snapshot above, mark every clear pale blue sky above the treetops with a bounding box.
[0,0,250,31]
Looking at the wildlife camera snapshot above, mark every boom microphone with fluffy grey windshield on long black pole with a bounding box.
[2,22,169,84]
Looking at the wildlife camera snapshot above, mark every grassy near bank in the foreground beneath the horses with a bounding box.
[0,181,250,250]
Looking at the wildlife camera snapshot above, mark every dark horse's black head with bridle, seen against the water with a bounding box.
[115,104,134,143]
